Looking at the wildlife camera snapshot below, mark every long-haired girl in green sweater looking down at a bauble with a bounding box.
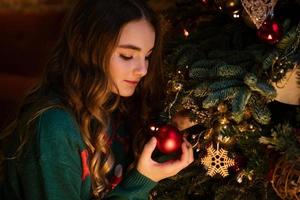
[0,0,193,200]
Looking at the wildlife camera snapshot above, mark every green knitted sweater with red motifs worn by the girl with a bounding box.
[0,108,156,200]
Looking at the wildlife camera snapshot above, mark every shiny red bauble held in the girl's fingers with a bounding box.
[155,125,183,154]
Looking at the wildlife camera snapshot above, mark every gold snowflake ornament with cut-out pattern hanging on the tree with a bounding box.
[201,144,235,177]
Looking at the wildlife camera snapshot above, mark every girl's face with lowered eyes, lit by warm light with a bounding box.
[109,19,155,97]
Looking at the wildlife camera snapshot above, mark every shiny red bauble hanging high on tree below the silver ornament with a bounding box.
[257,18,282,44]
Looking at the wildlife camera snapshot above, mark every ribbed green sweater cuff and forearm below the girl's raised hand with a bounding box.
[104,169,157,200]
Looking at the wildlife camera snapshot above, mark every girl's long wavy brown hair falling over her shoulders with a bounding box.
[0,0,163,197]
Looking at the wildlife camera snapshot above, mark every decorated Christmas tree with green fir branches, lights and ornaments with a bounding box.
[149,0,300,200]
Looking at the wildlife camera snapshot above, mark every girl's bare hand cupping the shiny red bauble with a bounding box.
[137,137,194,182]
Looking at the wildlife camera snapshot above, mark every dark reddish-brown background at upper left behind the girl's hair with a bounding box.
[0,0,68,130]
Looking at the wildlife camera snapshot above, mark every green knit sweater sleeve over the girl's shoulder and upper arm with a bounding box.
[18,109,90,200]
